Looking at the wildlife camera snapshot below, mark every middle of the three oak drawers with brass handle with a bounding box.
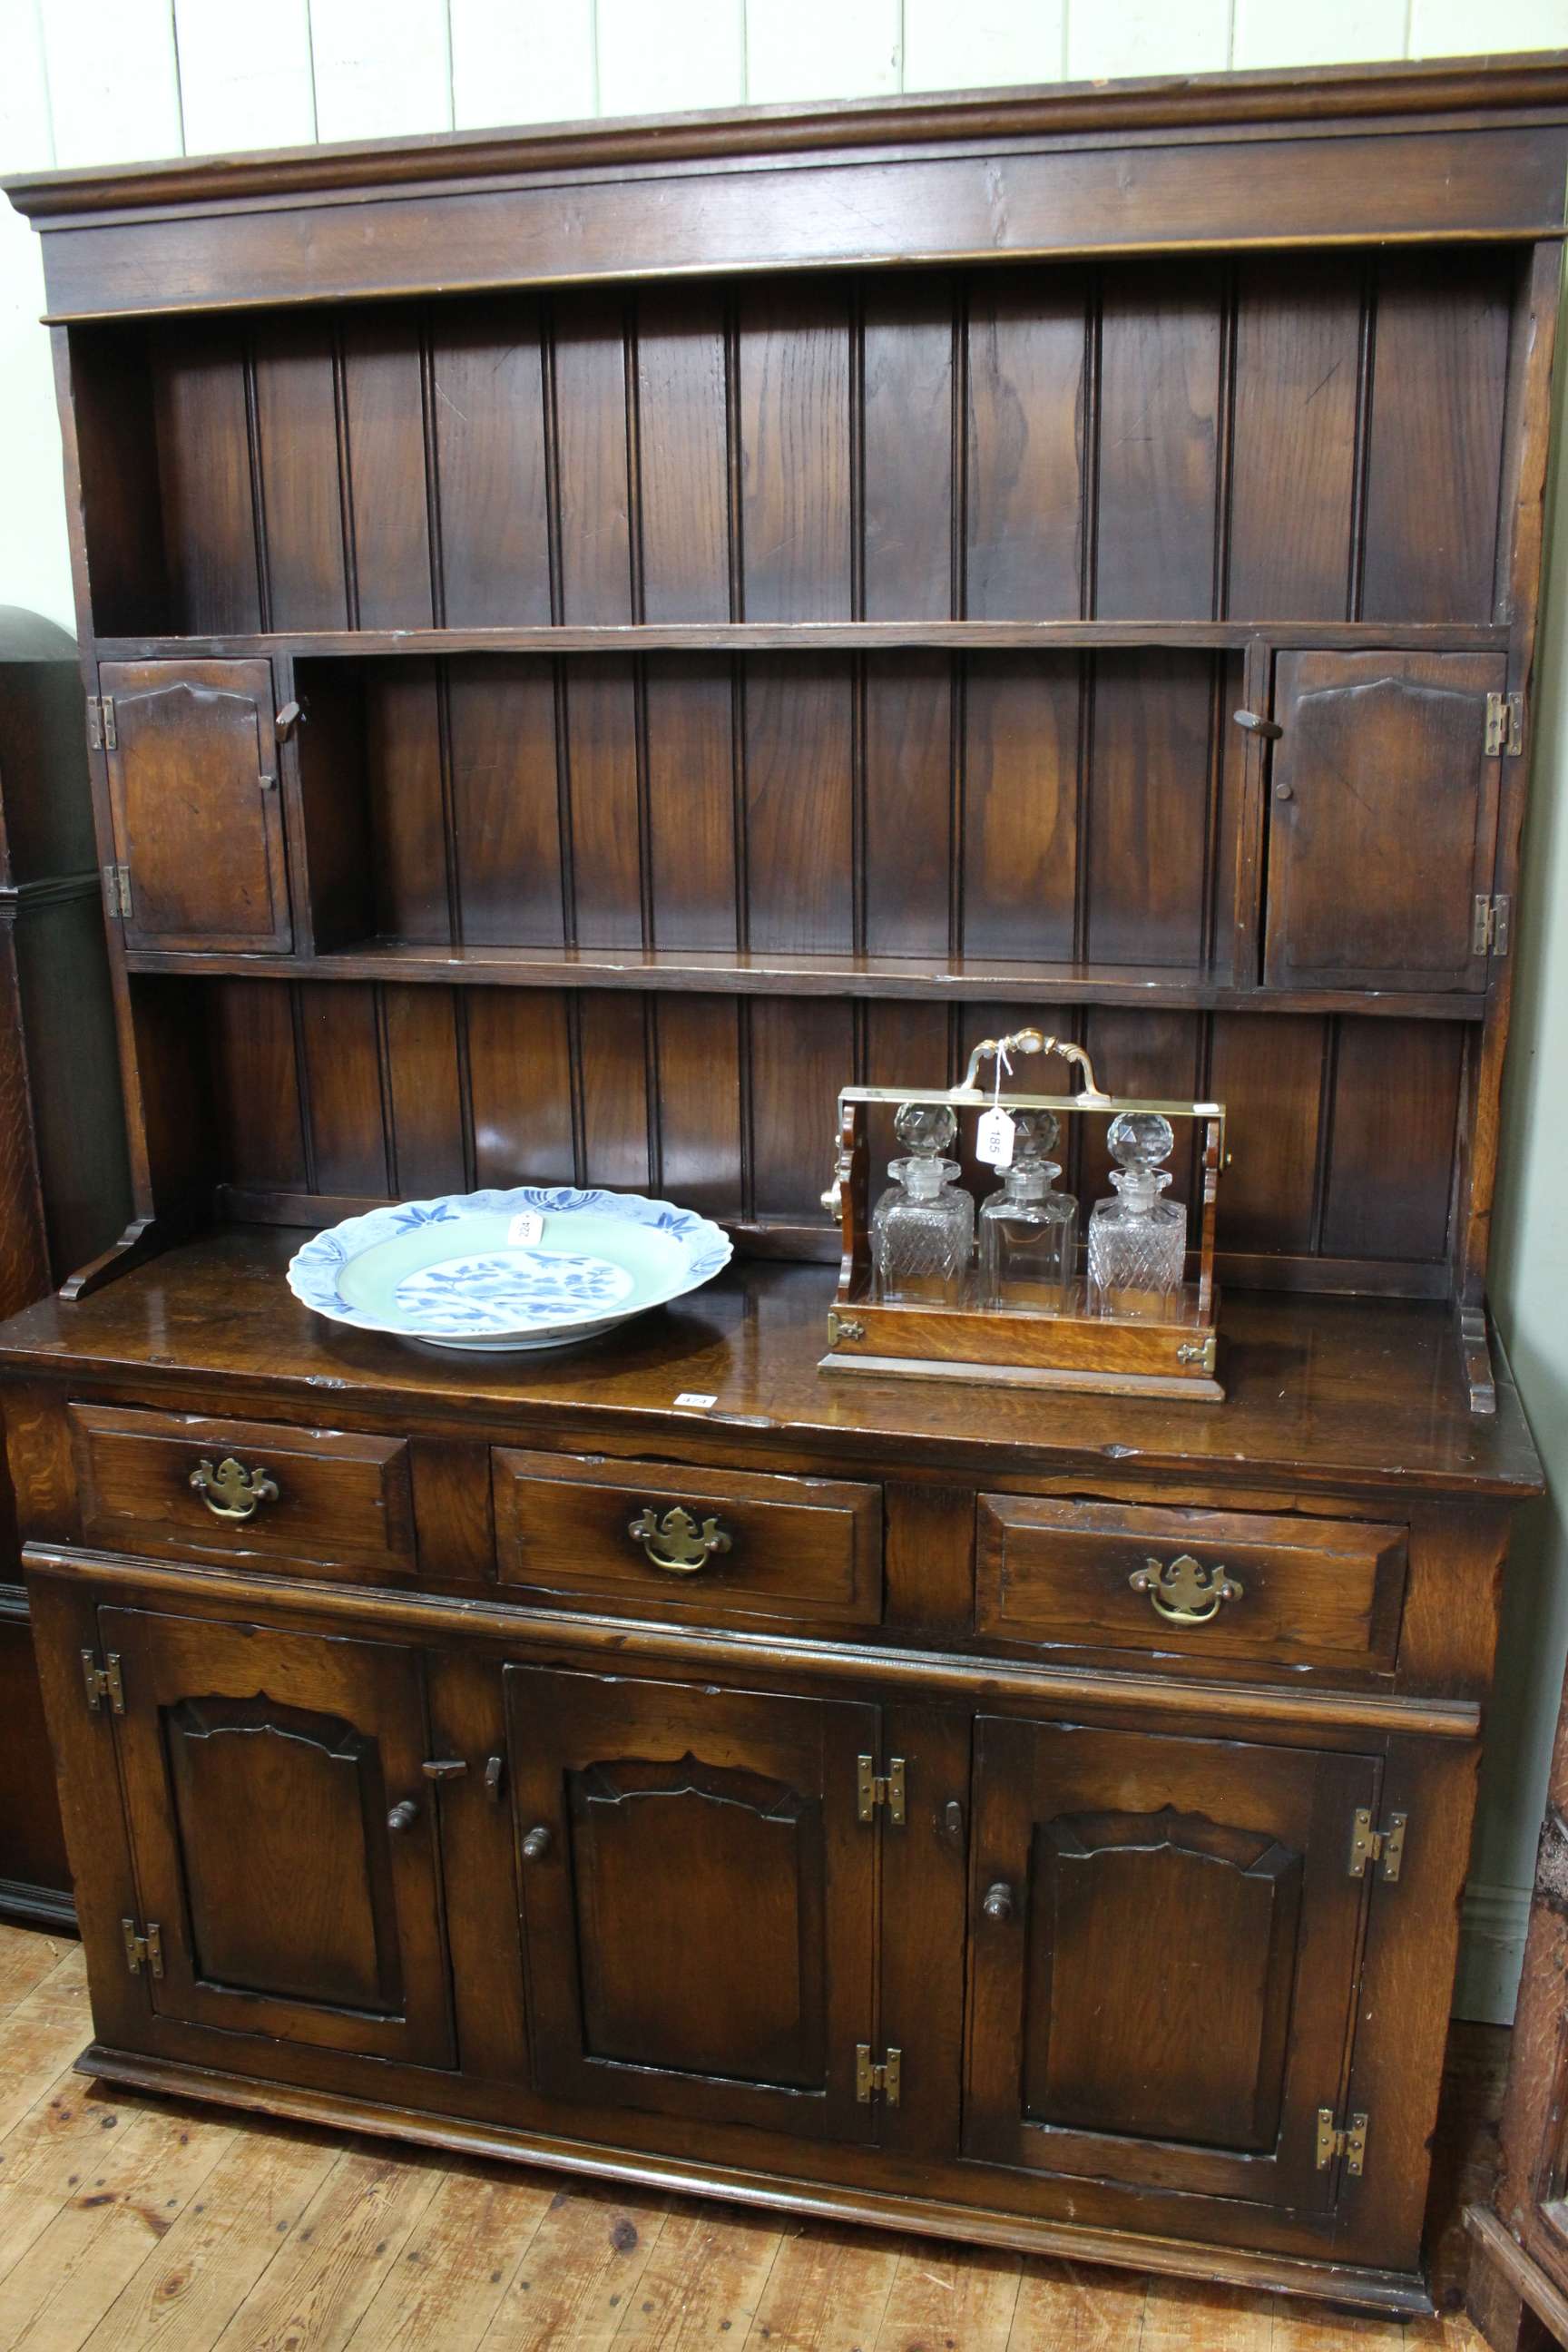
[491,1446,882,1625]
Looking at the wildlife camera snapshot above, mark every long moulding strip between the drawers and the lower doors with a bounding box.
[21,1543,1481,1740]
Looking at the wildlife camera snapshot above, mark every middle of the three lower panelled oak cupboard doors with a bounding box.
[505,1665,877,2141]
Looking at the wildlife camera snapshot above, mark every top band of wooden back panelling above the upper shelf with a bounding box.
[73,247,1516,635]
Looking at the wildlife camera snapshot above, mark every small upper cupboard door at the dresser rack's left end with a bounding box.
[99,661,294,948]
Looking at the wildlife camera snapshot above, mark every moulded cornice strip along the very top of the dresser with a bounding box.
[0,49,1568,221]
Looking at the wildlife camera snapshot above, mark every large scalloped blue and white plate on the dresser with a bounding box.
[289,1185,731,1348]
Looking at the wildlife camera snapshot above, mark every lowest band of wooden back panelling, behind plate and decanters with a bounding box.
[200,981,1472,1294]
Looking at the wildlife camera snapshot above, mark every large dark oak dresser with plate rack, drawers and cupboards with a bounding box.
[0,59,1568,2312]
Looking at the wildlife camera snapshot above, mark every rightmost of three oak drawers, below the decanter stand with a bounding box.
[975,1494,1406,1672]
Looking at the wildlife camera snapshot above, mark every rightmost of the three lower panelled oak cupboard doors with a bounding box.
[964,1717,1377,2210]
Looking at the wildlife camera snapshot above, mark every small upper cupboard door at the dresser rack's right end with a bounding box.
[1265,654,1507,990]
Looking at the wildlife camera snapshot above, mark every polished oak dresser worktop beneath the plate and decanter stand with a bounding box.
[0,1225,1540,1496]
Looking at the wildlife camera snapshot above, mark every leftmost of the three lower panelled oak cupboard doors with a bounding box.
[99,1609,456,2065]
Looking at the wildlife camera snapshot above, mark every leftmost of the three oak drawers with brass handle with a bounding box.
[71,1404,416,1583]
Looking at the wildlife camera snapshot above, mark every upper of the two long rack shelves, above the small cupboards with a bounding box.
[94,621,1509,661]
